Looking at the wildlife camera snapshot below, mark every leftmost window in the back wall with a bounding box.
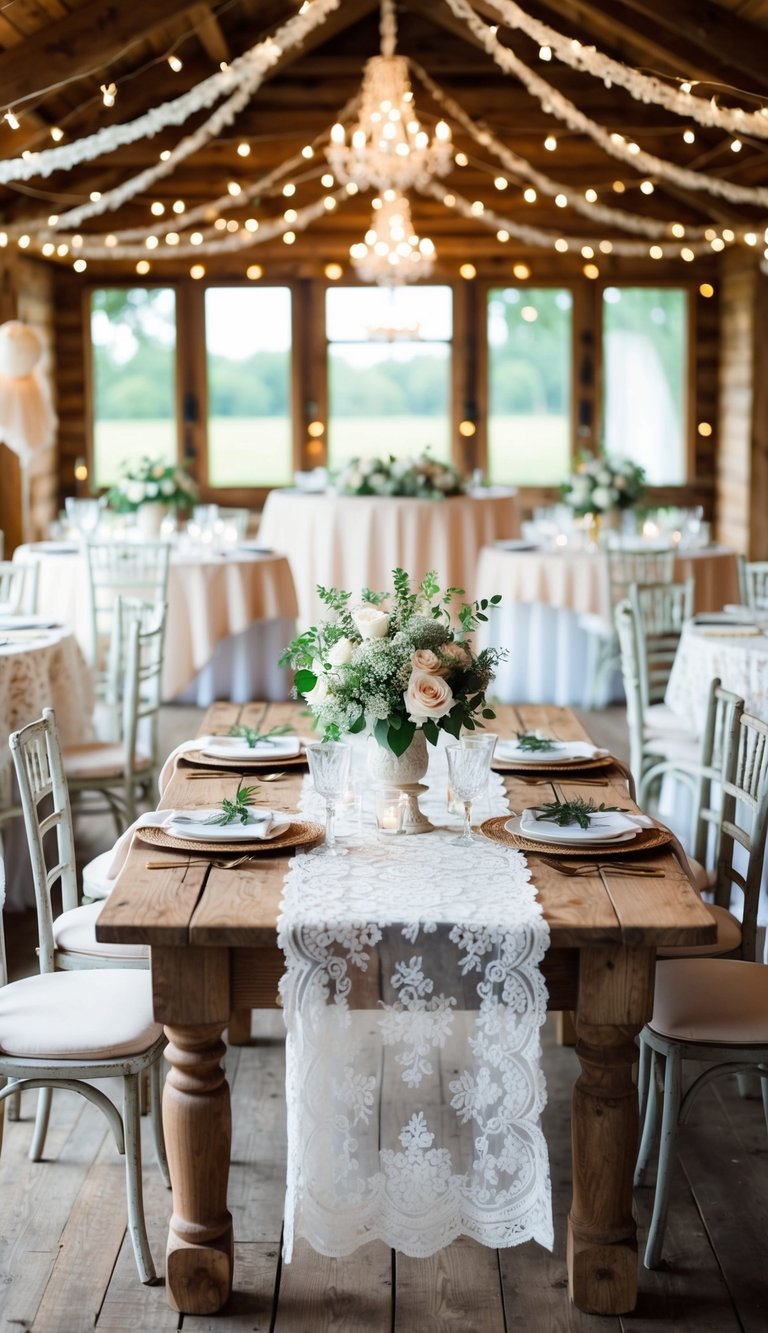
[91,287,177,487]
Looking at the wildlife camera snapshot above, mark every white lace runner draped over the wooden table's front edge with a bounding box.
[279,752,553,1261]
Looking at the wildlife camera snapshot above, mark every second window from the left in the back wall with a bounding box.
[205,287,293,487]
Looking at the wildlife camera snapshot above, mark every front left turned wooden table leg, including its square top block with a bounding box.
[152,946,232,1314]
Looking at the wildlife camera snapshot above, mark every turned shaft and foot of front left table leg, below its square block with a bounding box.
[163,1024,232,1314]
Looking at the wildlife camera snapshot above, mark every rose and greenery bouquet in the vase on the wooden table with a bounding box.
[281,569,505,756]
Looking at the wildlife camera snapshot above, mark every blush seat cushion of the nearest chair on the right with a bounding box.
[649,958,768,1046]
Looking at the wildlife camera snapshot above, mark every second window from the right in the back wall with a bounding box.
[488,287,573,485]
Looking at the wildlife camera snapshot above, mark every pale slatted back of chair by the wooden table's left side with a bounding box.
[9,708,77,972]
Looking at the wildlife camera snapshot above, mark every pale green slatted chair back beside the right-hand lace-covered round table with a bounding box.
[629,579,693,708]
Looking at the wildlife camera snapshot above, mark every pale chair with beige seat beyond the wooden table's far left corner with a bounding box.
[64,597,167,833]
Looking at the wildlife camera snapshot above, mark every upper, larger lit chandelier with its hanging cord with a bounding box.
[325,0,453,191]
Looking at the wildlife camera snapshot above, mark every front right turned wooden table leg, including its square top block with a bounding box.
[568,945,655,1314]
